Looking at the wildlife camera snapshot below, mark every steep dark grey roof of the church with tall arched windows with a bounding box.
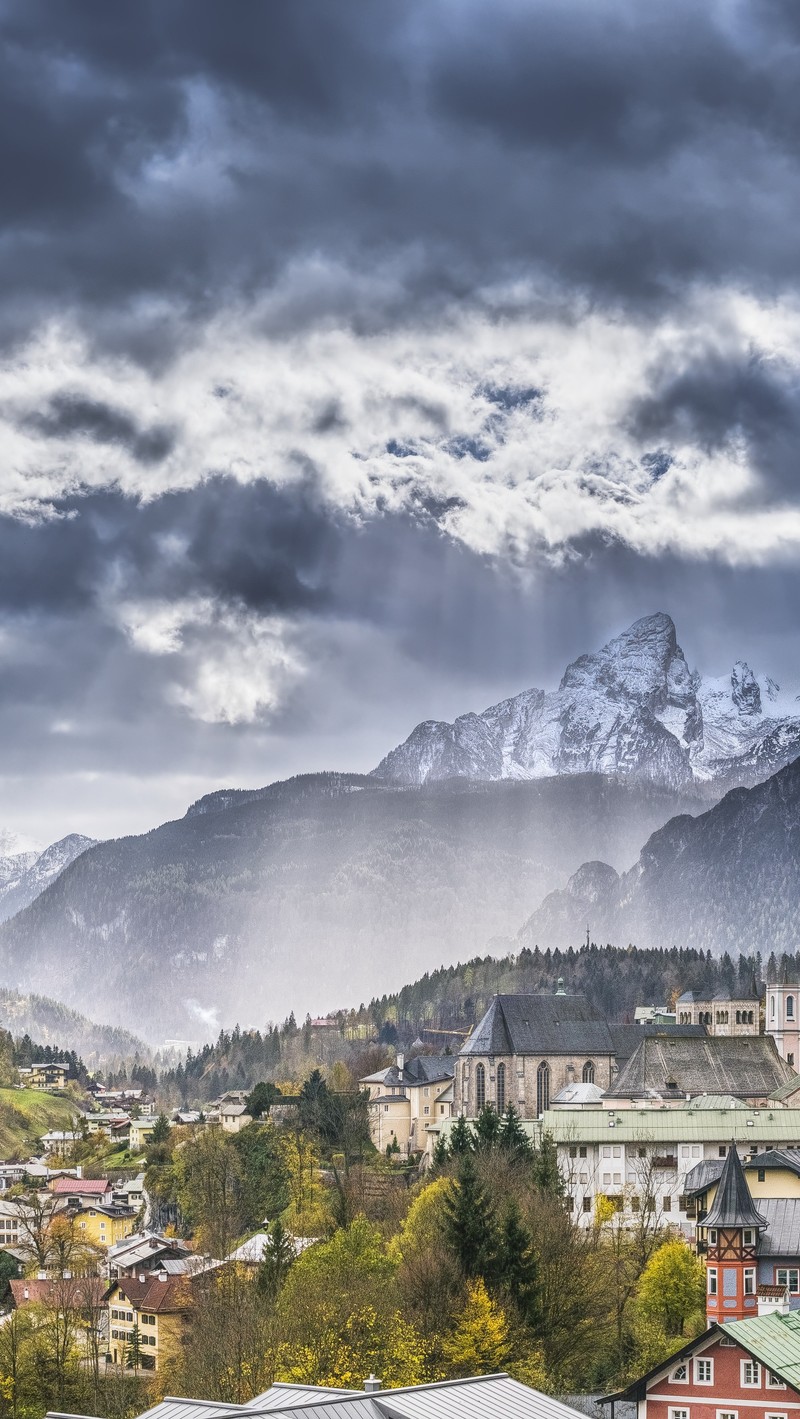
[461,995,614,1056]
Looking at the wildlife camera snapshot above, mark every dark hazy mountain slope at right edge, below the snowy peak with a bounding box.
[519,759,800,955]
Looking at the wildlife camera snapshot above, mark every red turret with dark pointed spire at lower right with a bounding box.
[696,1144,767,1325]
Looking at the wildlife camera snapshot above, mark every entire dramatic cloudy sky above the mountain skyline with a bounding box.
[0,0,800,840]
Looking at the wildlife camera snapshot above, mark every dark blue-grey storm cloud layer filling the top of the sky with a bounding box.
[0,0,800,346]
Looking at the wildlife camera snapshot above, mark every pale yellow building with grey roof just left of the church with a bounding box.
[359,1054,455,1156]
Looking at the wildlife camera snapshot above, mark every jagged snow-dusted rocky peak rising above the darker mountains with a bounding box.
[373,612,800,789]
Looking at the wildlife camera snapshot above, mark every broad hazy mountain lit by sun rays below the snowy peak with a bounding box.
[0,775,708,1042]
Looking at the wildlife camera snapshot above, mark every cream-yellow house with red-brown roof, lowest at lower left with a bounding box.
[106,1271,191,1369]
